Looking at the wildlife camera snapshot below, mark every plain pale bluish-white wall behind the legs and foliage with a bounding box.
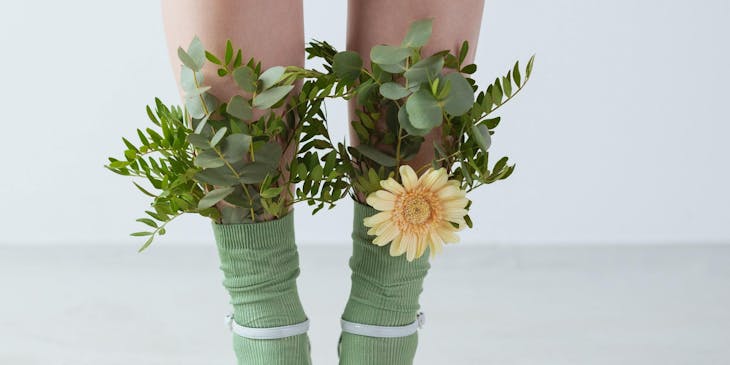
[0,0,730,247]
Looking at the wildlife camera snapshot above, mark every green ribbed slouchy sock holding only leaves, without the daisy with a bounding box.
[213,213,312,365]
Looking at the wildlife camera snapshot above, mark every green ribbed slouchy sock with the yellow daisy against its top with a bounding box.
[339,202,431,365]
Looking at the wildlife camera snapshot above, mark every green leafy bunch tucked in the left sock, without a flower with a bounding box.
[106,37,349,251]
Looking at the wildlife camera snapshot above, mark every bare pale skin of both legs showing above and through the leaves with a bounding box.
[162,0,484,208]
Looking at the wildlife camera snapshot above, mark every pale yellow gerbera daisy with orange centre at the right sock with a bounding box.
[363,165,469,261]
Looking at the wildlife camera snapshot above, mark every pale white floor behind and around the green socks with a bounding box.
[0,242,730,365]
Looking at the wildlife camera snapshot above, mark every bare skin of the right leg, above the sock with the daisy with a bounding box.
[347,0,484,167]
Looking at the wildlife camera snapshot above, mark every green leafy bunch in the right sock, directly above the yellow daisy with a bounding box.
[307,19,534,203]
